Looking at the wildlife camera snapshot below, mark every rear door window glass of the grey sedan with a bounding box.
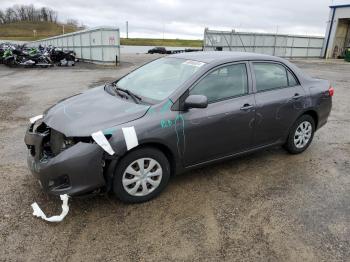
[253,62,288,92]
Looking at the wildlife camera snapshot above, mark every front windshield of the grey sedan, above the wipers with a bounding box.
[117,57,204,101]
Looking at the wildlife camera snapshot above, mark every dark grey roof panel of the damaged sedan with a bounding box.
[169,51,284,63]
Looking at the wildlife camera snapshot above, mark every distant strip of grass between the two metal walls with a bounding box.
[120,38,203,47]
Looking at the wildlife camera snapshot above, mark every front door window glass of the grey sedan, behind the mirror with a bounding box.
[190,64,248,103]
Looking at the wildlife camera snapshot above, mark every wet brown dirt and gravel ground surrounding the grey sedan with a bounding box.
[0,55,350,261]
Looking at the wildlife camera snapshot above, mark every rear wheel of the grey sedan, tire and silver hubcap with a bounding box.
[285,115,315,154]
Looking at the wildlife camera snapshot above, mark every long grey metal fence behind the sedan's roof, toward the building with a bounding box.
[203,29,324,57]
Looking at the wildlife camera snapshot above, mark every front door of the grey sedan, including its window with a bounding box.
[183,62,255,166]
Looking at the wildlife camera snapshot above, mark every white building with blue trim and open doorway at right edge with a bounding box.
[323,4,350,58]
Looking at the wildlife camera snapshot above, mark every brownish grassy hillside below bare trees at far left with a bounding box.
[0,22,79,41]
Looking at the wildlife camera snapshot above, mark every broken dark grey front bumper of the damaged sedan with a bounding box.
[24,119,106,196]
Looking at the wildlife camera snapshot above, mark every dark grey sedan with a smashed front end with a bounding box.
[25,52,334,202]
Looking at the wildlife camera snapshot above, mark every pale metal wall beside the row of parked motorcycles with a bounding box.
[30,27,120,64]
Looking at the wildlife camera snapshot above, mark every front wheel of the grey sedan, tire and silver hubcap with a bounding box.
[113,147,170,203]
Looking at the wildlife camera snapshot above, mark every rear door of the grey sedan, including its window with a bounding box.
[250,61,306,147]
